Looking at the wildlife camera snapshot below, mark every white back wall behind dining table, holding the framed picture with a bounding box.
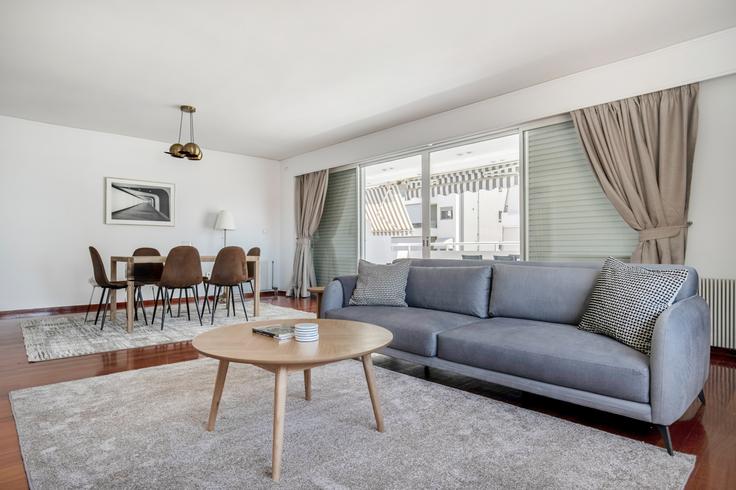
[0,116,281,311]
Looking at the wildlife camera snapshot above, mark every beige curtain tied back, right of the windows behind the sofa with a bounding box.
[572,83,698,264]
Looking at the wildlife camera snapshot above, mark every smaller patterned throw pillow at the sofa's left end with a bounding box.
[350,260,409,306]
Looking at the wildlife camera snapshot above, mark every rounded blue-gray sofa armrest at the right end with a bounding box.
[649,296,710,425]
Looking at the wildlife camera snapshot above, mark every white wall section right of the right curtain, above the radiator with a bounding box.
[686,75,736,279]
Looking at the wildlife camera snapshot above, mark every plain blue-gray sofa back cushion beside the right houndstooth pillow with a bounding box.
[490,264,600,324]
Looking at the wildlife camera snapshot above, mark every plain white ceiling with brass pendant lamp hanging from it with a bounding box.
[0,0,736,159]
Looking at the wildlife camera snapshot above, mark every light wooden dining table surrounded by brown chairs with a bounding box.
[110,255,261,333]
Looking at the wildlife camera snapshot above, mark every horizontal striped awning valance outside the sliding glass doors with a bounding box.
[400,161,519,199]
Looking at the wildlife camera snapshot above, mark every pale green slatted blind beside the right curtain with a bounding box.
[525,121,638,261]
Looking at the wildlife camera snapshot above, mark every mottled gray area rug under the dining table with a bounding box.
[20,301,315,362]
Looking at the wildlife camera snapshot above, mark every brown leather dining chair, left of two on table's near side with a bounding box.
[151,246,202,330]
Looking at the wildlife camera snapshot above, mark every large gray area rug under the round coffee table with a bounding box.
[10,359,695,489]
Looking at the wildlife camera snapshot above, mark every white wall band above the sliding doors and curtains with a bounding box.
[281,28,736,284]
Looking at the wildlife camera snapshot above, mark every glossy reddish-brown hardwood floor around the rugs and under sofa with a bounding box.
[0,296,736,489]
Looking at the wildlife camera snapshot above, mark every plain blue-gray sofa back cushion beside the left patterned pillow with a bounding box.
[406,266,491,318]
